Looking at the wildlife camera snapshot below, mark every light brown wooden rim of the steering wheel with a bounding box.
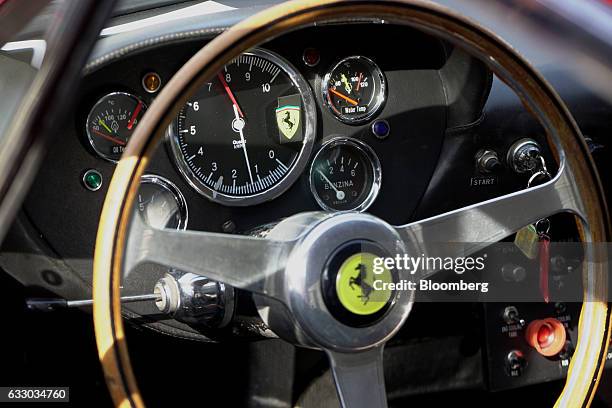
[93,0,610,407]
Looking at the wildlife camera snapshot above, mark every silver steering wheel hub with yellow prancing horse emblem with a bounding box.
[267,212,414,352]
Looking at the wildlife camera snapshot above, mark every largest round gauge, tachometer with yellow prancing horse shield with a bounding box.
[170,50,316,205]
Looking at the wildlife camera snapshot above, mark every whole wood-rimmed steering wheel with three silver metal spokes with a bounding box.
[94,0,610,408]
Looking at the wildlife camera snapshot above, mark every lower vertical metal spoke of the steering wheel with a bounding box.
[326,345,387,408]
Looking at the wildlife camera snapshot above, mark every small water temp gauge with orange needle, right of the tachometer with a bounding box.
[322,56,386,124]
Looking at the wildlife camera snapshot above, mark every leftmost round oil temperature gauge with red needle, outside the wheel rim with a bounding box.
[86,92,146,162]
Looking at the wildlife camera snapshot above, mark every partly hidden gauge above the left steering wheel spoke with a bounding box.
[135,174,188,230]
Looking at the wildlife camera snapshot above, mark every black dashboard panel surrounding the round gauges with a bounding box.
[25,24,490,259]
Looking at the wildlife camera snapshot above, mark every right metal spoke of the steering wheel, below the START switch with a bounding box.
[396,162,586,262]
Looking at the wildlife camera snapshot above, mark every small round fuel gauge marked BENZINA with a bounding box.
[310,137,382,211]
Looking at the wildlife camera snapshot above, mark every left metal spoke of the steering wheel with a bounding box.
[123,216,294,298]
